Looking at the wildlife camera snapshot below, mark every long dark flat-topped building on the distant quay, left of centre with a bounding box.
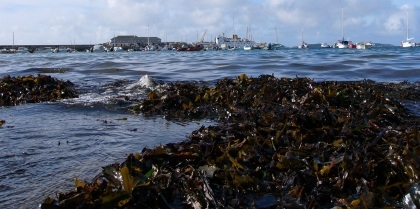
[108,36,161,47]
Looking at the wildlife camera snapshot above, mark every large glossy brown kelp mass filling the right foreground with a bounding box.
[42,75,420,208]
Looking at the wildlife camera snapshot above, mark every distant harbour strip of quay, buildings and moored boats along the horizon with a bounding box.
[0,33,420,54]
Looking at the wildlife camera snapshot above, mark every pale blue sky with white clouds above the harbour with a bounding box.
[0,0,420,46]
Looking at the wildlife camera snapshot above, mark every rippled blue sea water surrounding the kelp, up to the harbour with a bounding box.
[0,47,420,208]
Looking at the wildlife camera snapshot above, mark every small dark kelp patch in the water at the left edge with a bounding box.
[0,74,78,106]
